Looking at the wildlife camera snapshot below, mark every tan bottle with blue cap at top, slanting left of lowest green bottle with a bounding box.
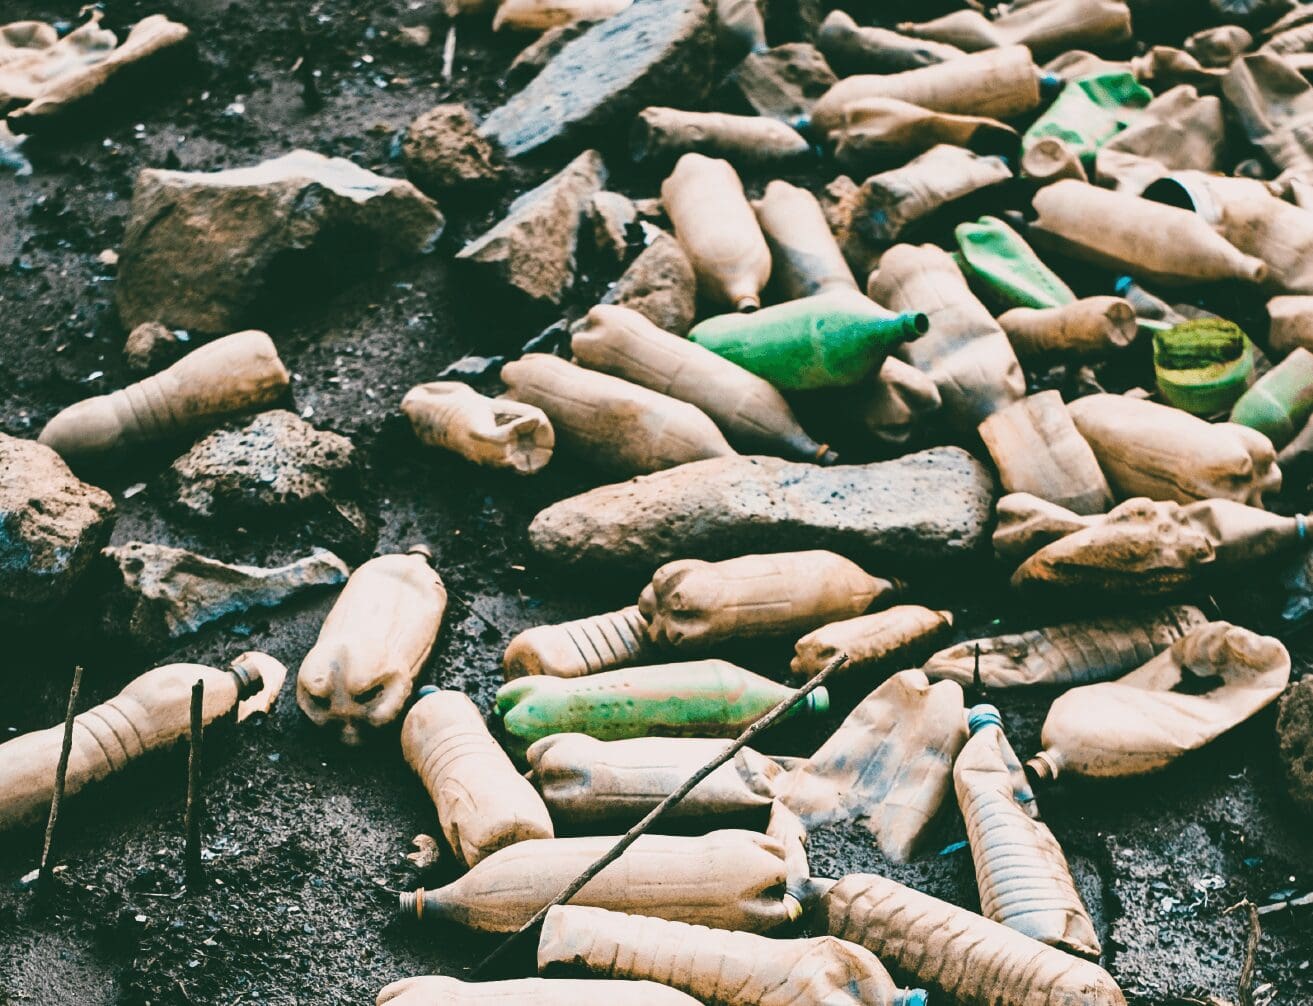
[402,688,555,867]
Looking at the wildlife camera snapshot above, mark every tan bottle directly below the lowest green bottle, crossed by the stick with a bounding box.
[527,734,784,827]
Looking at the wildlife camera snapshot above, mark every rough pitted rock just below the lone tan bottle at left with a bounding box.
[165,408,376,558]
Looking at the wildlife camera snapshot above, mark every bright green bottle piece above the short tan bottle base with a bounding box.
[953,217,1075,309]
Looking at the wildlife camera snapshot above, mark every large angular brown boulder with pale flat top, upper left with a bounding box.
[116,150,444,332]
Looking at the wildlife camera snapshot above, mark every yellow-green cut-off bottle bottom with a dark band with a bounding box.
[1153,318,1254,416]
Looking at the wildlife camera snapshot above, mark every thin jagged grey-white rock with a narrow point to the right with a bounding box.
[104,541,351,647]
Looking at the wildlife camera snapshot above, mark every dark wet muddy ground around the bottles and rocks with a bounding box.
[0,0,1313,1006]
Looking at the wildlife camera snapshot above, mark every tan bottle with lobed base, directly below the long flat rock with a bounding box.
[638,549,905,649]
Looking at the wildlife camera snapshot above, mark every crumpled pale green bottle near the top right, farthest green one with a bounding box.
[1022,71,1153,171]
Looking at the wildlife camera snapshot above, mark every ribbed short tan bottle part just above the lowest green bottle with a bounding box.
[502,604,657,680]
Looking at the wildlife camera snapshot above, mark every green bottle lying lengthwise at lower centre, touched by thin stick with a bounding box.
[496,661,830,747]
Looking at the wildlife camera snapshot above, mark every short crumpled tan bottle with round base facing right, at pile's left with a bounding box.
[402,381,557,475]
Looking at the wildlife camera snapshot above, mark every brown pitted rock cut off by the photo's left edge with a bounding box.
[0,433,114,607]
